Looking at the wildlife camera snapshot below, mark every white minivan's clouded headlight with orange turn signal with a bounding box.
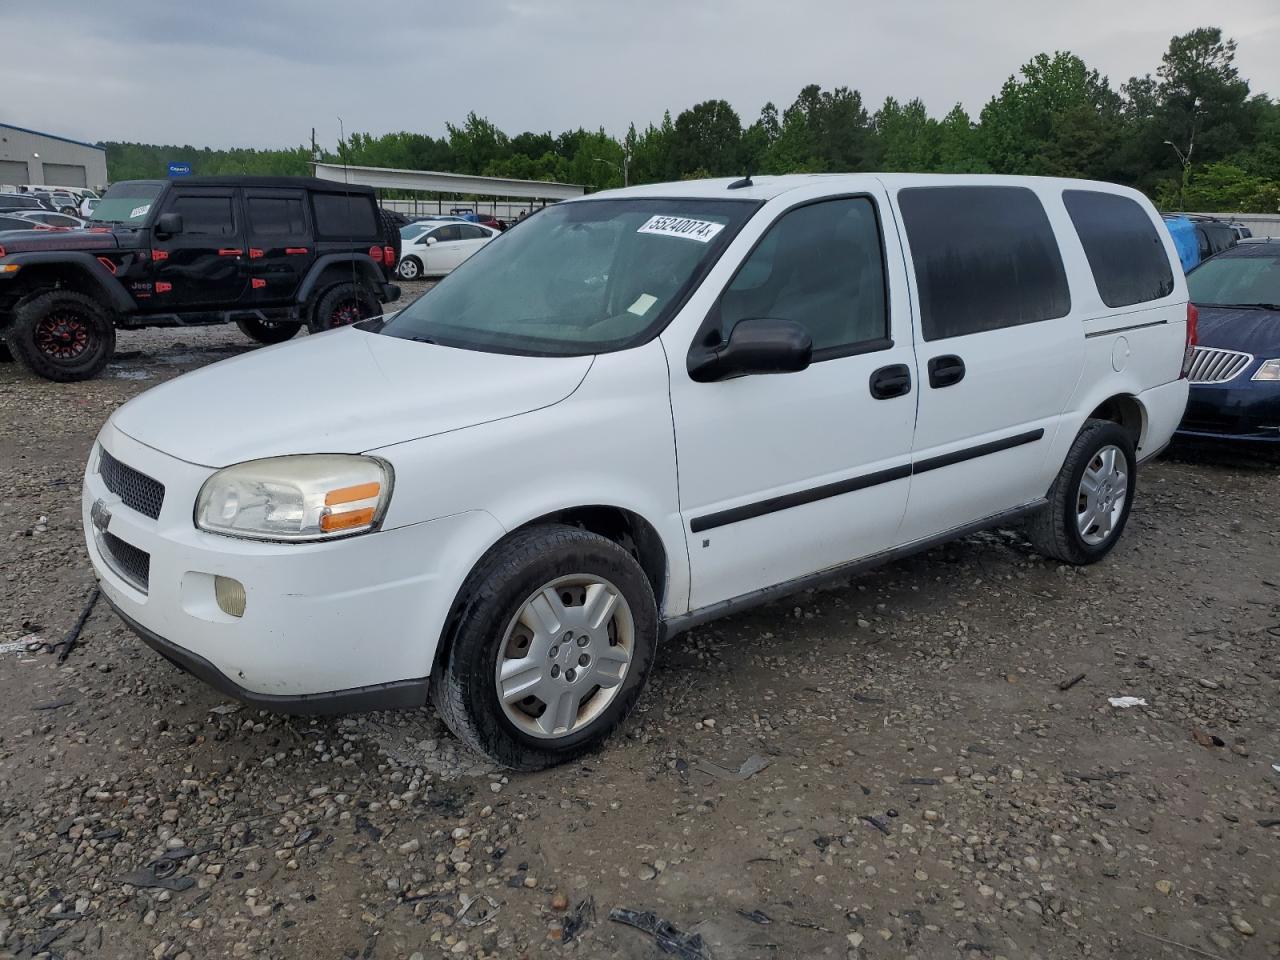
[196,453,393,540]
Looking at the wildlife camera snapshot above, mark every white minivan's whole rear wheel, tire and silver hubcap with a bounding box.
[1027,420,1138,564]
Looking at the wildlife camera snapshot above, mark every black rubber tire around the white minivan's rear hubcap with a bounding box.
[1027,420,1138,566]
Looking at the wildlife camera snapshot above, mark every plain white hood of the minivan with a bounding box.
[111,328,591,467]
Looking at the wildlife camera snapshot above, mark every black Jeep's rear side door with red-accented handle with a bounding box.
[243,187,315,306]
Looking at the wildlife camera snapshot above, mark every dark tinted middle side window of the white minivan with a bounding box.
[897,187,1071,340]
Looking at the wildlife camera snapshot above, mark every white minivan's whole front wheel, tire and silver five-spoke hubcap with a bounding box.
[431,525,658,771]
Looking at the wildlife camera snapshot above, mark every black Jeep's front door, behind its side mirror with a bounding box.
[151,187,248,311]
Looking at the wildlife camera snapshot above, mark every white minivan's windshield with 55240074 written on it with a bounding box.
[381,197,759,356]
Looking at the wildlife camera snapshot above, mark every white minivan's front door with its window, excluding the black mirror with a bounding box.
[664,189,916,609]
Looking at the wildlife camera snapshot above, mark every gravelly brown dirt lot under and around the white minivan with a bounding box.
[0,293,1280,960]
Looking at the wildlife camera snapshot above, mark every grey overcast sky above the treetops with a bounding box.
[0,0,1280,146]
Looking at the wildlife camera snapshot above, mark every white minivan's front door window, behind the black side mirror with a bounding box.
[721,197,888,356]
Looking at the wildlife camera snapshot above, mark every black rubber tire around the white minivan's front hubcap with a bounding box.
[431,525,658,771]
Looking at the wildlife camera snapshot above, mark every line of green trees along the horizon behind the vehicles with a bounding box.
[102,27,1280,212]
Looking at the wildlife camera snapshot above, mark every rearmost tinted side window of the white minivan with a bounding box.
[1062,189,1174,307]
